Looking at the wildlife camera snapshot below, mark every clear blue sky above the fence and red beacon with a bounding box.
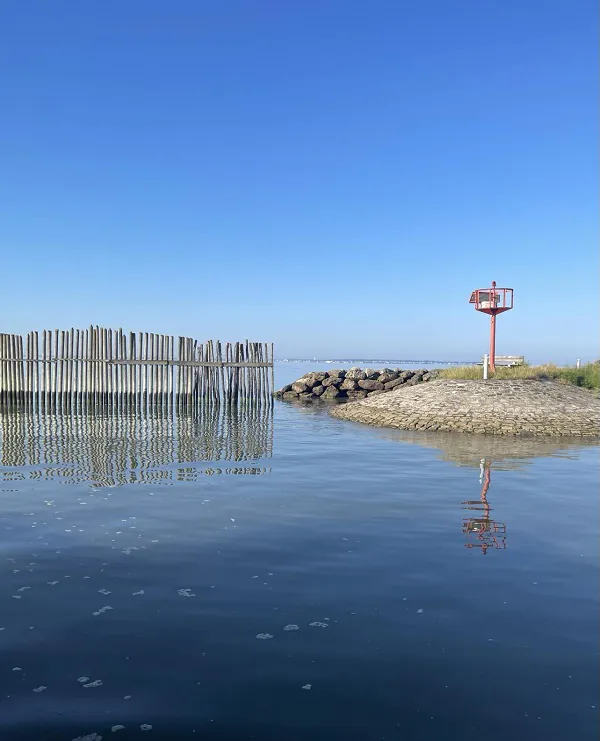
[0,0,598,362]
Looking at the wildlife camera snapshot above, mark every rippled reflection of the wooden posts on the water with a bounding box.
[0,403,273,487]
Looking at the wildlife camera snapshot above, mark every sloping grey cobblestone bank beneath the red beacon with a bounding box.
[331,380,600,437]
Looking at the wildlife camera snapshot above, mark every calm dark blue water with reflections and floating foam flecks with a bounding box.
[0,368,598,741]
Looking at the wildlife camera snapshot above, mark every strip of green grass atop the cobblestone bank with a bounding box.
[438,362,600,391]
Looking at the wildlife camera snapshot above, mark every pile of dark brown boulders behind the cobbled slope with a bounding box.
[275,368,439,401]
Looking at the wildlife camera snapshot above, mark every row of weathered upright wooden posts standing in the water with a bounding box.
[0,327,273,409]
